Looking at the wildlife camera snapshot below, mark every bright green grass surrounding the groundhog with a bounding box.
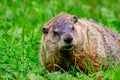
[0,0,120,80]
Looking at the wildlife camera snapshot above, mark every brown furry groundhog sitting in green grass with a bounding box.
[40,13,120,72]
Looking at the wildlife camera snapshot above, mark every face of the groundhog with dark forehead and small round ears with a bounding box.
[43,16,78,50]
